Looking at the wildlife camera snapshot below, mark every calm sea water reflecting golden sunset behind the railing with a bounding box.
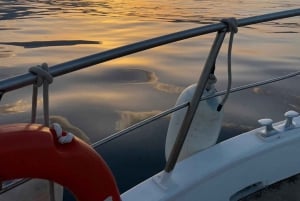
[0,0,300,195]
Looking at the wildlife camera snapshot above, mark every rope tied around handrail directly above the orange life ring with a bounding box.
[29,63,53,126]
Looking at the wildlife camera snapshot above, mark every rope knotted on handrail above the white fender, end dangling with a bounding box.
[217,18,238,111]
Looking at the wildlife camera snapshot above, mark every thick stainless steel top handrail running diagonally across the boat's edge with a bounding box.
[0,8,300,94]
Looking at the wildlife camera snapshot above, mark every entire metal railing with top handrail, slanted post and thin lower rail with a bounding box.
[0,8,300,194]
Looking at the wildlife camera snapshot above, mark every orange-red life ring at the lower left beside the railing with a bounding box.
[0,124,121,201]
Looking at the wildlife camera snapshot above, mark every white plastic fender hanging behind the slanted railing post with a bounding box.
[165,84,224,161]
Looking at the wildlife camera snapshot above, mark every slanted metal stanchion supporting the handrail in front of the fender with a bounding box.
[164,31,226,172]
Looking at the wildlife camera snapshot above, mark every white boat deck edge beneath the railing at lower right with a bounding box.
[122,117,300,201]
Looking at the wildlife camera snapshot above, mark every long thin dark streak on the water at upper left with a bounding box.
[0,40,101,48]
